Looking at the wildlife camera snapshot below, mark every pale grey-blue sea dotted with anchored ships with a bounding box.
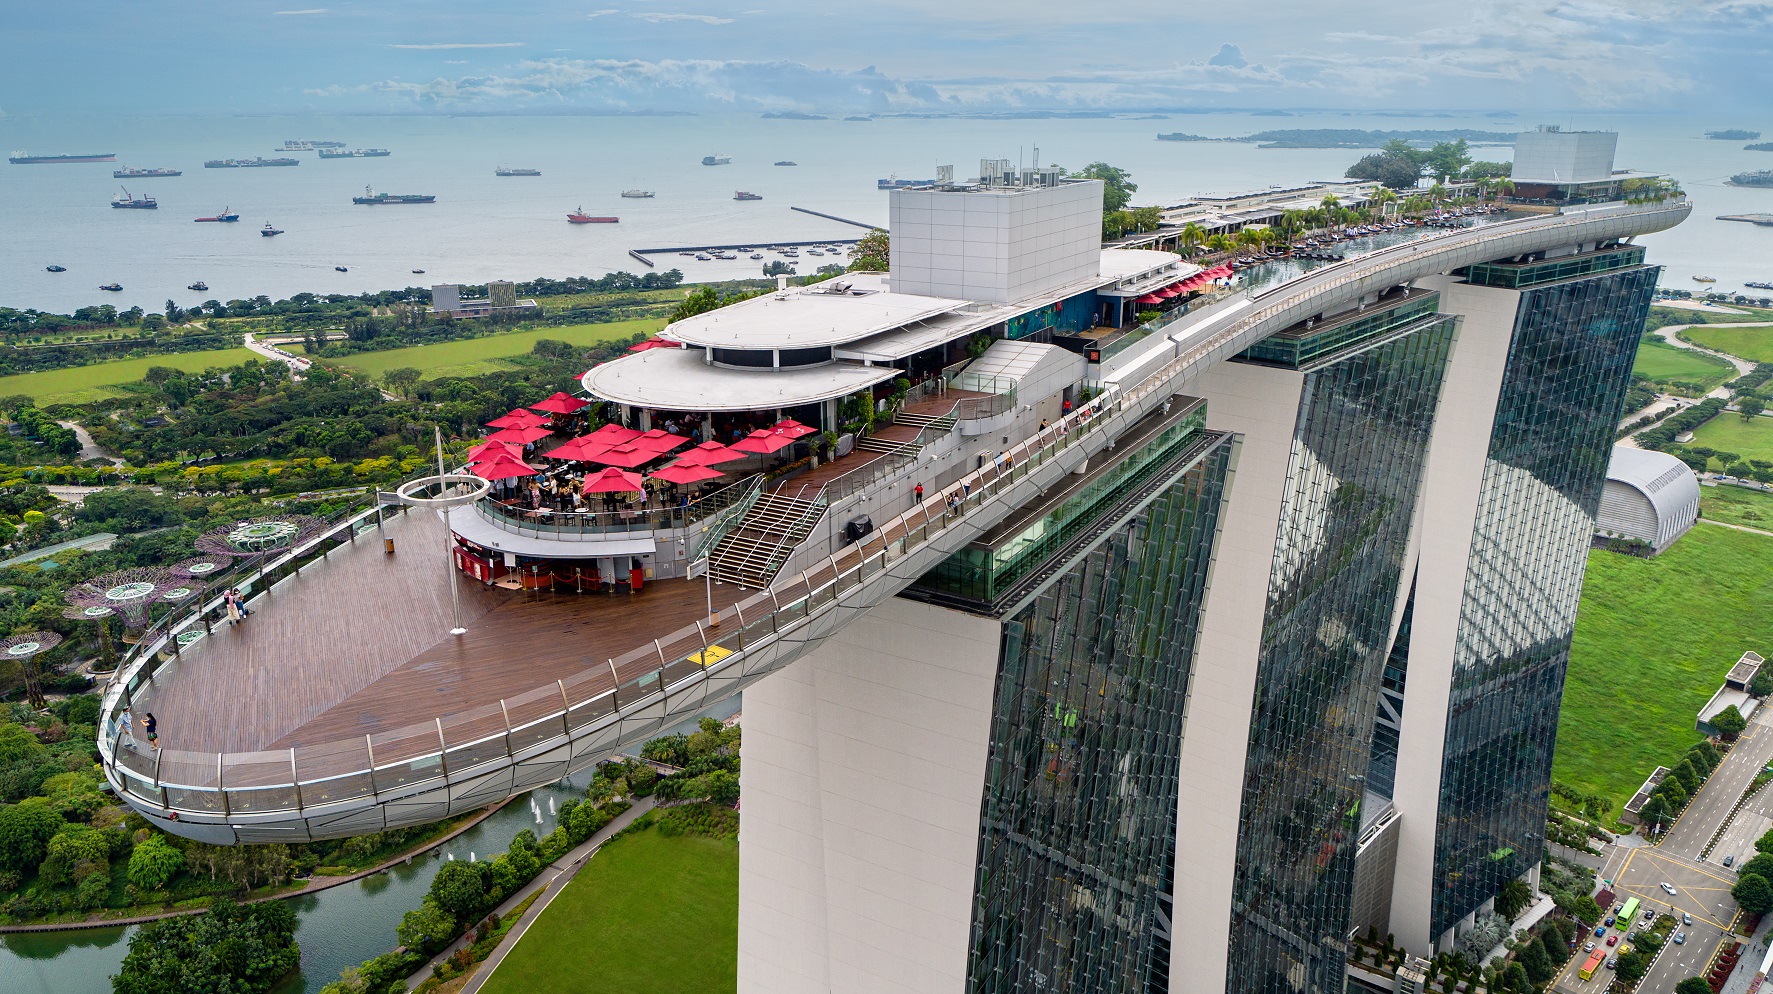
[0,113,1773,312]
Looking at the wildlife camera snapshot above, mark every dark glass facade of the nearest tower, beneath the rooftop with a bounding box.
[968,436,1232,994]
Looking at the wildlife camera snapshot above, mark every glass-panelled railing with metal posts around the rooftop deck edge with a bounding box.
[99,199,1687,822]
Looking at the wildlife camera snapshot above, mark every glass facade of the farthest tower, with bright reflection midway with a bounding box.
[1431,260,1660,936]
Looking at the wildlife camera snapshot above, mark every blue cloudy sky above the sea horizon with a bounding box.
[0,0,1773,116]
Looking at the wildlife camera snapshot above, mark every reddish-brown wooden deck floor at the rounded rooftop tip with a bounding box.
[137,512,741,751]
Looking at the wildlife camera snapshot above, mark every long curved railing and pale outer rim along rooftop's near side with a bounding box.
[99,195,1674,840]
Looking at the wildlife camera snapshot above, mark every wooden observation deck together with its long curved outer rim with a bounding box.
[99,202,1690,842]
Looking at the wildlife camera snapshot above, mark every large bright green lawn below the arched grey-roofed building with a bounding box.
[1551,524,1773,815]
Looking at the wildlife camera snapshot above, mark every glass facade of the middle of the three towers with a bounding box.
[1227,315,1456,994]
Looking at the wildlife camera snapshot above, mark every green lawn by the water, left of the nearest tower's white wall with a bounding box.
[480,822,734,994]
